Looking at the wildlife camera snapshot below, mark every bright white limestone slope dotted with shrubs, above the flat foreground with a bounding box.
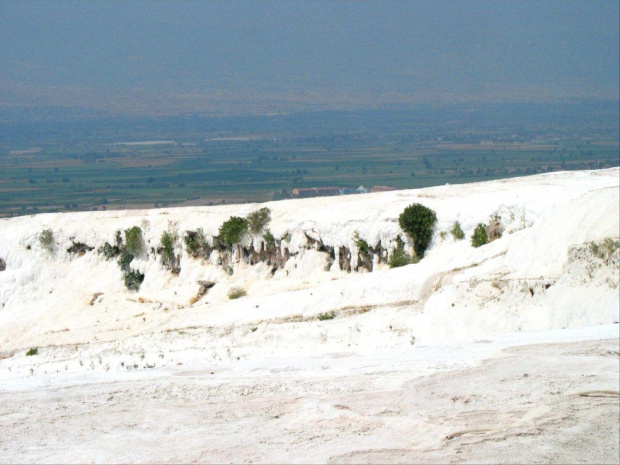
[0,169,620,350]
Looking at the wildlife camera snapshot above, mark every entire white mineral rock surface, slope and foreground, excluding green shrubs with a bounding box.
[0,168,620,463]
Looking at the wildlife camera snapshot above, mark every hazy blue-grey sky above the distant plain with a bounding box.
[0,0,620,112]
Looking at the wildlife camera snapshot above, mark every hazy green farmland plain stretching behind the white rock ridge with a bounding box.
[0,105,620,216]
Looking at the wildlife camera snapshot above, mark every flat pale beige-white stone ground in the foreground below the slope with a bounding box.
[0,325,620,463]
